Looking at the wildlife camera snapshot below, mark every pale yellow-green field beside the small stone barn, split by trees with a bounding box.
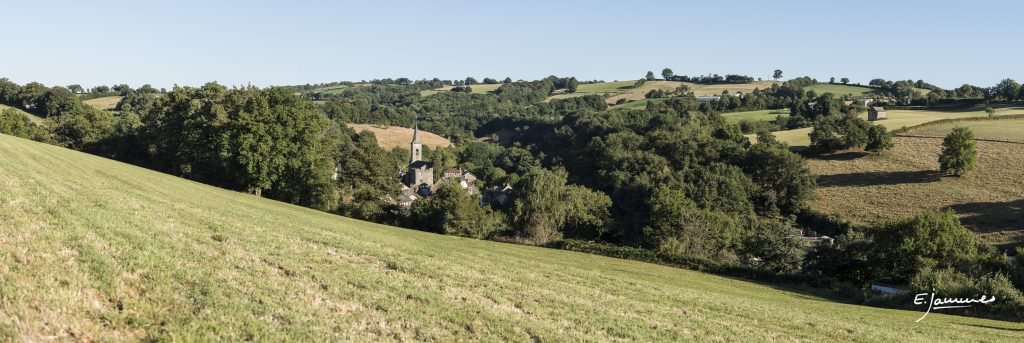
[773,106,1024,147]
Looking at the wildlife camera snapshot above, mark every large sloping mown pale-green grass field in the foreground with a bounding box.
[0,136,1024,342]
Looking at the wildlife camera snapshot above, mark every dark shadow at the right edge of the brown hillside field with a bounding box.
[947,199,1024,232]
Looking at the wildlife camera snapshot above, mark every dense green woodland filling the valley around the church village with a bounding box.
[0,73,1024,321]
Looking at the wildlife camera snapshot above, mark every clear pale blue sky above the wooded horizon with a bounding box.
[0,0,1024,88]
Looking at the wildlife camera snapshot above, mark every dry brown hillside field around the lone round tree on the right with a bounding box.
[808,137,1024,245]
